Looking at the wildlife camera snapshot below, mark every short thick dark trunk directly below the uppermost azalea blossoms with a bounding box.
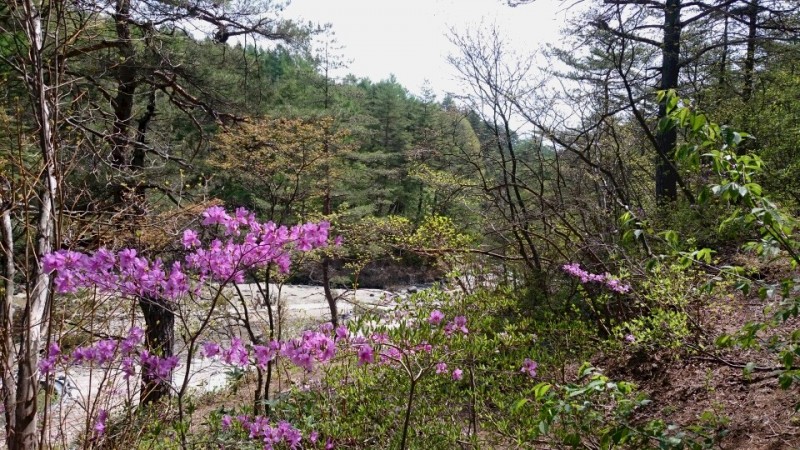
[139,297,175,406]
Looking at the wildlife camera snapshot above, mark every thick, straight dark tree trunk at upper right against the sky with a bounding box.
[656,0,681,204]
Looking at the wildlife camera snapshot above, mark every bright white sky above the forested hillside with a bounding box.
[282,0,568,99]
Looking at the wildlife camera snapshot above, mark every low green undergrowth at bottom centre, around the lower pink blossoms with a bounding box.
[184,290,724,449]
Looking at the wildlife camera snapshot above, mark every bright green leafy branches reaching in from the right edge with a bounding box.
[648,92,800,389]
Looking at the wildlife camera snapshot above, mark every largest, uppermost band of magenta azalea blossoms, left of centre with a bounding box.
[42,206,330,300]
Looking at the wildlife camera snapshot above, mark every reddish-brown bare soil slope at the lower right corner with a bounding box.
[595,268,800,450]
